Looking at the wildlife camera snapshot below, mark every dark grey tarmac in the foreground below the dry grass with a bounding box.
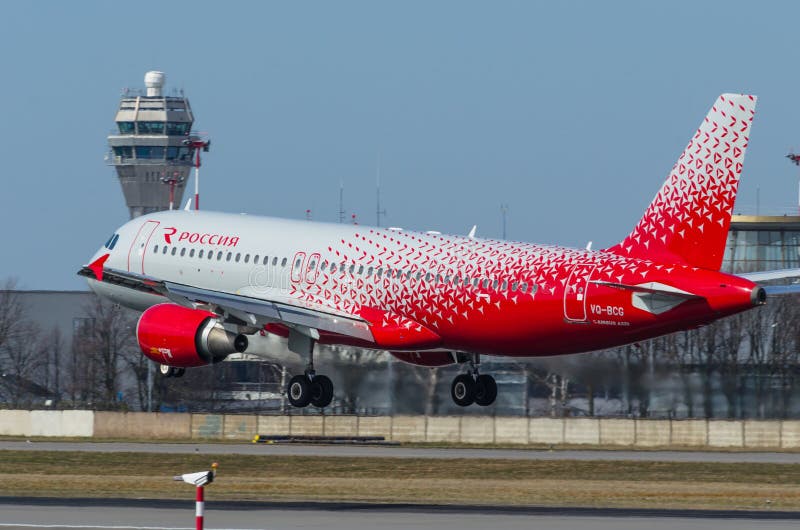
[0,494,800,530]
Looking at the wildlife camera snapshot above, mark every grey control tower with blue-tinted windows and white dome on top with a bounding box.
[106,71,207,219]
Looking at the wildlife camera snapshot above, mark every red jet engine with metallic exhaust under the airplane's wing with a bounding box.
[136,304,247,368]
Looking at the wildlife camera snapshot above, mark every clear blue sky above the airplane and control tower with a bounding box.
[0,1,800,289]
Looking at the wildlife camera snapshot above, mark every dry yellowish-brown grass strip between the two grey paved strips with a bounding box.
[0,451,800,510]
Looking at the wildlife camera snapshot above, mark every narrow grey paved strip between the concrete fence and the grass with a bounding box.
[0,441,800,464]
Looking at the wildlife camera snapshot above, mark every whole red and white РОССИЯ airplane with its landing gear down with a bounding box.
[79,94,789,407]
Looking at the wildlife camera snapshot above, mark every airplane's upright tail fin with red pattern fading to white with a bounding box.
[607,94,756,270]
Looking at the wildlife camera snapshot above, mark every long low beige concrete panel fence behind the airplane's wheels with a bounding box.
[0,410,800,450]
